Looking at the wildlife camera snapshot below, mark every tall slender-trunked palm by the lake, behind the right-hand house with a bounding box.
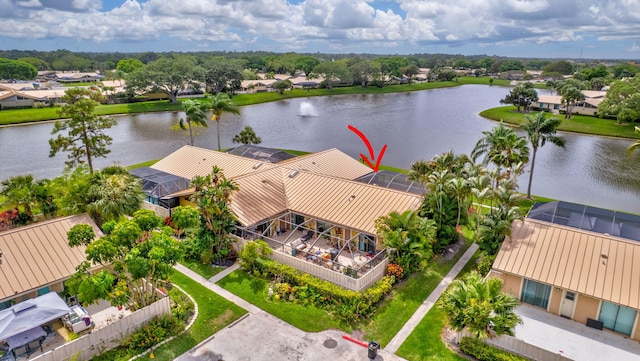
[521,112,565,198]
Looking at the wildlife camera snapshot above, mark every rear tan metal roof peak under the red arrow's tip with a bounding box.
[278,148,372,179]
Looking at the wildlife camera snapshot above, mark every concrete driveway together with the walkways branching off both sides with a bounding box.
[175,244,478,361]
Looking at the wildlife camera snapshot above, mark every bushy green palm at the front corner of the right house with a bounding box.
[440,271,522,338]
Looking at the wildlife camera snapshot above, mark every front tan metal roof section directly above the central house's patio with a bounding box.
[231,167,421,234]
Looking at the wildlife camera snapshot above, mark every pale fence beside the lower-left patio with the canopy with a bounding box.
[31,297,171,361]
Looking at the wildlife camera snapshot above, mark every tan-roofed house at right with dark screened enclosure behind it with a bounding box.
[489,202,640,341]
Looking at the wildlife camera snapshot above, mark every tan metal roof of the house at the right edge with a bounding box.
[493,219,640,309]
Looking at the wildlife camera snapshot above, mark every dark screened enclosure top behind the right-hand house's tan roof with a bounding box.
[527,201,640,241]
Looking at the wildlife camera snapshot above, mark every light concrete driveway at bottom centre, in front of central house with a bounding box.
[176,312,404,361]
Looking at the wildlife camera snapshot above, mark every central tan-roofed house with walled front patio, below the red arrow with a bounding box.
[140,146,421,291]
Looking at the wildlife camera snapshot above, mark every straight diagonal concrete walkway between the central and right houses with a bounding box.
[384,243,478,353]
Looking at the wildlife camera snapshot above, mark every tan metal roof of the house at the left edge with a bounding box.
[0,214,102,301]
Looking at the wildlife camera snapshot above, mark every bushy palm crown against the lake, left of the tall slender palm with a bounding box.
[471,123,529,183]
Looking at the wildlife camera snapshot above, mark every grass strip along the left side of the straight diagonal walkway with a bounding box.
[361,242,471,347]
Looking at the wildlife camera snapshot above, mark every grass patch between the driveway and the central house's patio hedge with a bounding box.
[218,270,341,332]
